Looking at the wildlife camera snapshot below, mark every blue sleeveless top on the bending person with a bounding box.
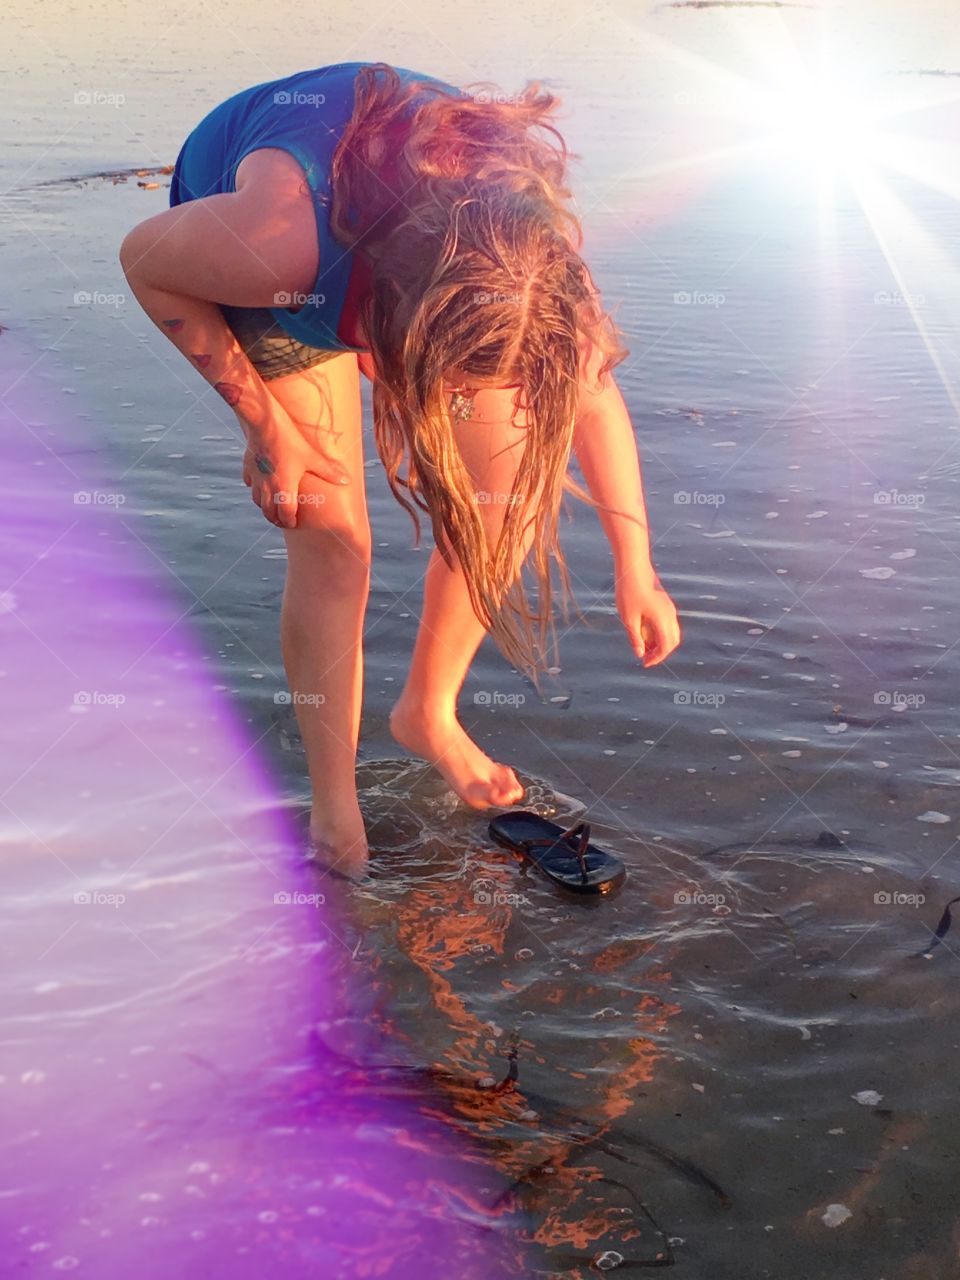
[170,63,467,351]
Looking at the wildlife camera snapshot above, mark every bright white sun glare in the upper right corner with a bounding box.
[621,6,960,415]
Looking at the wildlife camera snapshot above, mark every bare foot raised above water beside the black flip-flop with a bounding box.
[390,695,524,809]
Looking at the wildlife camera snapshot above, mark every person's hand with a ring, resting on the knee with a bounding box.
[237,406,349,529]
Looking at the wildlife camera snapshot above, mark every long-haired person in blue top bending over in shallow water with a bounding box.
[120,63,680,874]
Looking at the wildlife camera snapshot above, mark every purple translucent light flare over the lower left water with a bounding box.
[0,333,522,1280]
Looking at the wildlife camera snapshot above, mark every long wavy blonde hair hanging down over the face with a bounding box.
[330,63,627,681]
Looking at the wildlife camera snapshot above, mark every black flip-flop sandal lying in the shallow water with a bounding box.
[489,809,627,893]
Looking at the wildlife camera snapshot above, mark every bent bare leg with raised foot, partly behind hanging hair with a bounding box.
[390,392,542,809]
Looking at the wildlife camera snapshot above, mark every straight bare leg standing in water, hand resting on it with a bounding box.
[269,353,371,874]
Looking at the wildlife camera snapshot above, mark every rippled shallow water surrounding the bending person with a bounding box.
[0,5,960,1280]
